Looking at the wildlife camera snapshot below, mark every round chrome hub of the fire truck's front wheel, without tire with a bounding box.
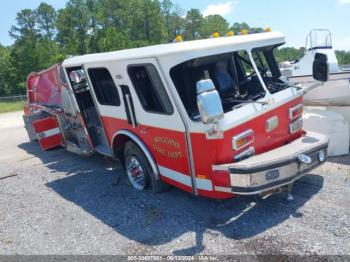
[126,156,146,190]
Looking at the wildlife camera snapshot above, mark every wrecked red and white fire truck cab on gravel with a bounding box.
[24,32,328,199]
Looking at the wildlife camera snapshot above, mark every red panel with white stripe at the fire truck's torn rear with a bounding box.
[33,116,63,150]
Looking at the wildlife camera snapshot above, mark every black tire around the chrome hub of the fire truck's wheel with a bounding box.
[123,141,169,194]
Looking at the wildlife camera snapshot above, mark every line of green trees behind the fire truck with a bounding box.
[0,0,350,96]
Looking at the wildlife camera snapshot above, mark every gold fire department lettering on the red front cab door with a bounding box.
[153,137,182,159]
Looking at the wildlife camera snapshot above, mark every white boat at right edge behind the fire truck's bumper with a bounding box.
[280,29,350,156]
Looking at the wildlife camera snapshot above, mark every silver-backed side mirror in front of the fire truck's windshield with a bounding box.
[197,79,224,124]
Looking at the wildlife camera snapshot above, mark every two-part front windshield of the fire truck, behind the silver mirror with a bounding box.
[170,47,285,121]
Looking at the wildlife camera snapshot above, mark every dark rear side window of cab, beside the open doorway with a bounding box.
[88,68,120,106]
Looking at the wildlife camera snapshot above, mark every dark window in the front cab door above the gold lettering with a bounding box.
[128,64,174,114]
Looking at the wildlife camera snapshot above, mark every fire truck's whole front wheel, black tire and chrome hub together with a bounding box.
[124,141,169,193]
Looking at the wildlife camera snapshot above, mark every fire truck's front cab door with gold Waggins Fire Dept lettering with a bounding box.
[123,58,194,191]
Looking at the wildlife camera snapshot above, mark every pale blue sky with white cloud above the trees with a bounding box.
[0,0,350,51]
